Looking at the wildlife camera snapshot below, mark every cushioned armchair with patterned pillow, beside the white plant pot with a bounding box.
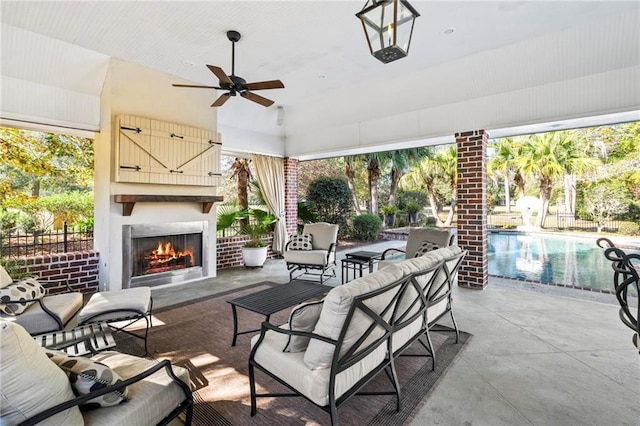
[284,222,338,284]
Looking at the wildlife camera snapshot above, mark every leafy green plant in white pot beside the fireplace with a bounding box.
[239,208,276,268]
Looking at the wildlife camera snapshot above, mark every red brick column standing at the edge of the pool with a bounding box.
[455,130,489,290]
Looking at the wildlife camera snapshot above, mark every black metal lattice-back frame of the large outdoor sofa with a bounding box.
[249,263,443,425]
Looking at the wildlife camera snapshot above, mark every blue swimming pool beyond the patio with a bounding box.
[488,232,634,293]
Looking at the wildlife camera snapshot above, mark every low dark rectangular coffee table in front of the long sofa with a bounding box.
[227,280,332,346]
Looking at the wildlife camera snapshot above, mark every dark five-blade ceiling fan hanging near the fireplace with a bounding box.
[173,31,284,107]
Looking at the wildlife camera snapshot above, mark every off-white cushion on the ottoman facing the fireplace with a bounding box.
[78,287,151,324]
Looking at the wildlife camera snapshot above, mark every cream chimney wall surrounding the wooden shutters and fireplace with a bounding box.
[94,59,224,290]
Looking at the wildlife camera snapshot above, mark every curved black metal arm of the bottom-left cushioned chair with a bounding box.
[20,359,193,426]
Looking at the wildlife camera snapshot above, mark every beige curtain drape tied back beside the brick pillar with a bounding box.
[252,155,287,253]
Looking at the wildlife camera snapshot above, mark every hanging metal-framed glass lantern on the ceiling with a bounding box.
[356,0,420,64]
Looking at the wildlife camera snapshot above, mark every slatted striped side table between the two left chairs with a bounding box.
[33,322,116,356]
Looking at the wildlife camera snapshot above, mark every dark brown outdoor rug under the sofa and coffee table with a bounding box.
[116,284,471,426]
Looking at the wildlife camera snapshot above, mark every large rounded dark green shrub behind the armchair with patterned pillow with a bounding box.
[307,177,352,236]
